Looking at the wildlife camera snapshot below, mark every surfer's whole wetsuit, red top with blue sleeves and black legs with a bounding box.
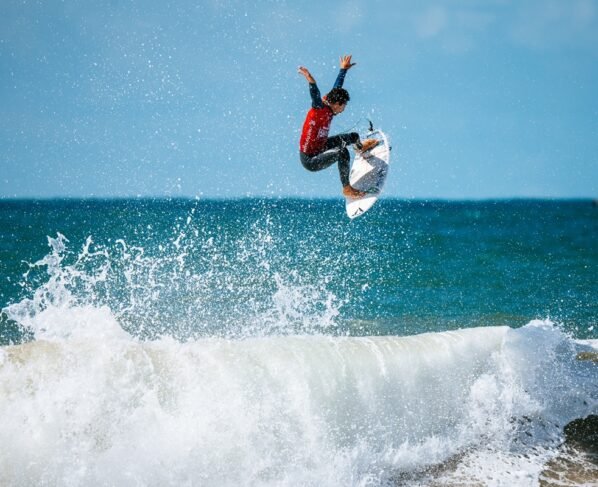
[299,69,359,187]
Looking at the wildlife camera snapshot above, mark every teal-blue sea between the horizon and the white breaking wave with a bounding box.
[0,199,598,343]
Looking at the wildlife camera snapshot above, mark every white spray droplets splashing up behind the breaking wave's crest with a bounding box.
[3,213,344,339]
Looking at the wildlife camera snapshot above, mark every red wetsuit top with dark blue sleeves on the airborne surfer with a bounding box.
[299,69,347,156]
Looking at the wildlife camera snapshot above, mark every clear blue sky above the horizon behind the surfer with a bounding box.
[0,0,598,199]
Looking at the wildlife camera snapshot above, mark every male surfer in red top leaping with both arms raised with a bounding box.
[299,55,378,198]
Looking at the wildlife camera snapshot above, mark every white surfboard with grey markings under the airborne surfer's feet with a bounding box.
[345,130,390,219]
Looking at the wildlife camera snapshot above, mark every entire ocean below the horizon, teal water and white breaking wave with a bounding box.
[0,199,598,486]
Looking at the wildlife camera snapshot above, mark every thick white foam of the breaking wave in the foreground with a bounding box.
[0,307,598,486]
